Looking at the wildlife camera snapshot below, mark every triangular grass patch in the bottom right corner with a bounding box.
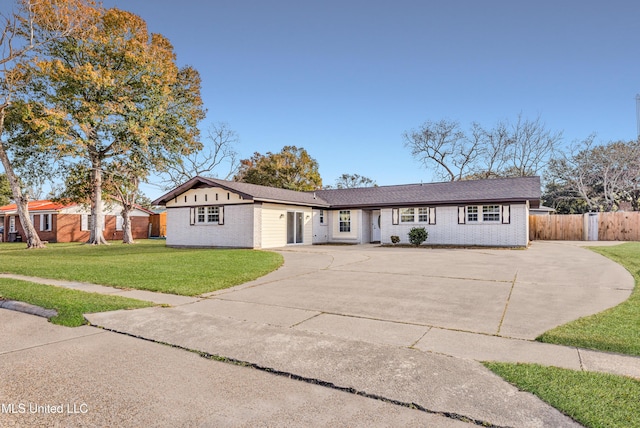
[484,362,640,428]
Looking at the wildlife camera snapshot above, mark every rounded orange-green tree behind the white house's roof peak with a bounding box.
[234,146,322,191]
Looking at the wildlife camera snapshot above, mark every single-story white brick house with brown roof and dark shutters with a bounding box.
[154,177,540,248]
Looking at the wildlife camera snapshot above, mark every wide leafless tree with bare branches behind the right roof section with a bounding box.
[403,115,562,181]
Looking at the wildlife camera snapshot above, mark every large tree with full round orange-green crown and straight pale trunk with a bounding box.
[29,8,204,244]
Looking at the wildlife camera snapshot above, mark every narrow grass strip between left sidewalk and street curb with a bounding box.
[0,278,153,327]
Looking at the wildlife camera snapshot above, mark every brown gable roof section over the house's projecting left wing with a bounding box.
[153,176,329,207]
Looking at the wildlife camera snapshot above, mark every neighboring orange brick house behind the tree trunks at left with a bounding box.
[0,200,153,242]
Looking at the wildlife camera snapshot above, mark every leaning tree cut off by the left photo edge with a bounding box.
[0,0,93,248]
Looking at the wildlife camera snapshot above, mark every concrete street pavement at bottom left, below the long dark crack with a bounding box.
[0,309,462,428]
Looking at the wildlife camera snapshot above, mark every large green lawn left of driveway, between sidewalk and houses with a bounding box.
[0,240,283,296]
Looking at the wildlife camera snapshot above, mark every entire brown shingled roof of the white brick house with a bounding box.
[153,177,541,208]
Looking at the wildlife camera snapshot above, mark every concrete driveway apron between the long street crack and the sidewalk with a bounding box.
[87,308,579,427]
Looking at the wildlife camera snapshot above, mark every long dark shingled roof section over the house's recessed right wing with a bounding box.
[316,177,541,208]
